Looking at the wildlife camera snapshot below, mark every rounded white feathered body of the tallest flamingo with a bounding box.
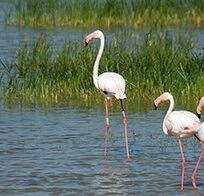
[98,72,126,99]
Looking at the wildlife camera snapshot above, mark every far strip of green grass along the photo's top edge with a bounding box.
[5,0,204,28]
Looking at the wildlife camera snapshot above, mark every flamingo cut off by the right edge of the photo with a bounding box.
[191,97,204,187]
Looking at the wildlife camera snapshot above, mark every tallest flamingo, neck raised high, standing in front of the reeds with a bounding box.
[85,30,130,159]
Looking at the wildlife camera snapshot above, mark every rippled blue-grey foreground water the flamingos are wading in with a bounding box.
[0,107,204,195]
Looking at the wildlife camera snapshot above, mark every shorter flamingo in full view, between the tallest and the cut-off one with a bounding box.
[154,92,200,190]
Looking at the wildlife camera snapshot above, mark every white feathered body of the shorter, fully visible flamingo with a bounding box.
[165,111,200,138]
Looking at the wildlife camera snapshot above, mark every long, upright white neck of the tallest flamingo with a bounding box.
[93,35,105,88]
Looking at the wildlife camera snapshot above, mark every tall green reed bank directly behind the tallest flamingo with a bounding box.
[0,32,204,107]
